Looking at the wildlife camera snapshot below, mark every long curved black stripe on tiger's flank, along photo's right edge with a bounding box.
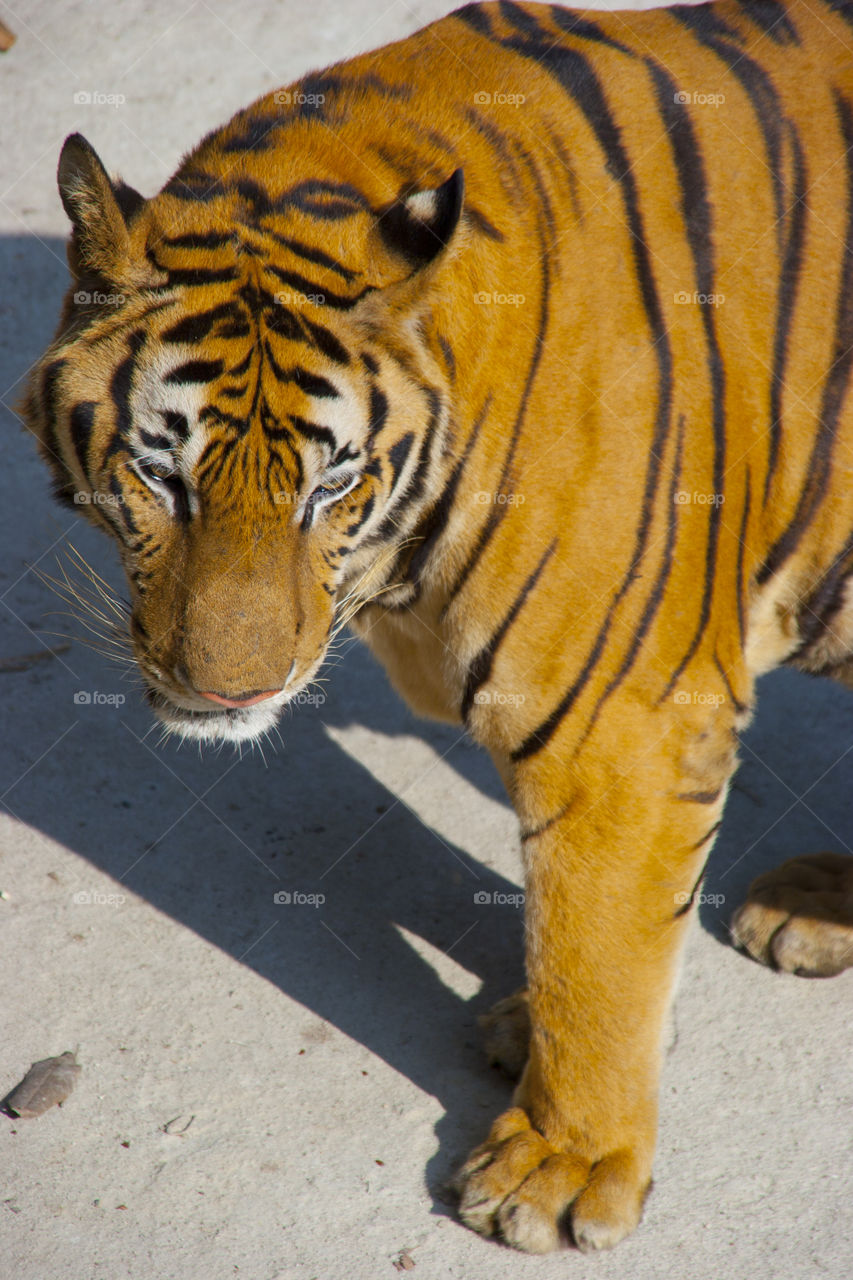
[757,91,853,584]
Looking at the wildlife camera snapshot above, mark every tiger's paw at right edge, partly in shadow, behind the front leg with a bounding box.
[731,854,853,978]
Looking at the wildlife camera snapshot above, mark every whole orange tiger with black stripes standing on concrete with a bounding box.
[22,0,853,1253]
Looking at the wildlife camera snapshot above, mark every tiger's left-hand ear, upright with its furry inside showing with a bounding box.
[56,133,145,282]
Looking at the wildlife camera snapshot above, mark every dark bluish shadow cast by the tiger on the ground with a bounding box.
[0,237,853,1211]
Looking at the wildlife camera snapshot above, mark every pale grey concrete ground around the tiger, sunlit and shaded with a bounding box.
[0,0,853,1280]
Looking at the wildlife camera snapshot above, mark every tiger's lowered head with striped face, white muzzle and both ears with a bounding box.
[23,134,462,741]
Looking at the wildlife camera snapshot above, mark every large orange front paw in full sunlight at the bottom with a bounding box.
[452,1107,651,1253]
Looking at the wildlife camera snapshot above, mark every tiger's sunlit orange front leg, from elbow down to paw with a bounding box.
[455,705,735,1253]
